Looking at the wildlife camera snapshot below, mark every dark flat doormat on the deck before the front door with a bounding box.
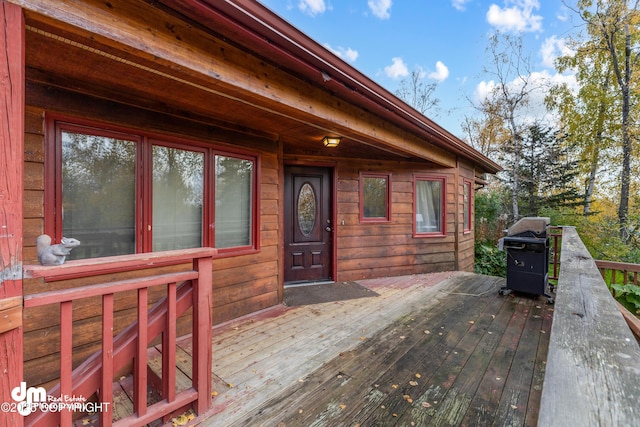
[284,282,380,307]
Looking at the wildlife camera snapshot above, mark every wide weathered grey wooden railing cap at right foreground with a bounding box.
[538,227,640,427]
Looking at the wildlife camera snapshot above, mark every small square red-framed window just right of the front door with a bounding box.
[360,172,391,221]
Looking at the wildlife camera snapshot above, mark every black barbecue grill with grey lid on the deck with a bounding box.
[499,217,554,304]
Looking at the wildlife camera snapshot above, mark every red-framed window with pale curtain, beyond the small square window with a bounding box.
[414,176,446,237]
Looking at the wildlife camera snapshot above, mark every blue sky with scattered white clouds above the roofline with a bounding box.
[259,0,577,137]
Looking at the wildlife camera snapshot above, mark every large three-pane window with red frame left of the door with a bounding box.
[50,122,258,259]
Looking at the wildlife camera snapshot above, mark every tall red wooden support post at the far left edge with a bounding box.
[0,0,25,426]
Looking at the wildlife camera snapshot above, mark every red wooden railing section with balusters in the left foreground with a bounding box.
[24,248,215,426]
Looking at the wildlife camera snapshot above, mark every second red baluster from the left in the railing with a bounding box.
[99,294,113,427]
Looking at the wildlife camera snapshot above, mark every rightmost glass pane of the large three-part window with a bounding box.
[215,155,254,248]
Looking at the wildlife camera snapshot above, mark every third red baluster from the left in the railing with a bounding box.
[133,288,148,416]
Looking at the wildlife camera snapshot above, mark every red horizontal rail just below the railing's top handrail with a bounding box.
[24,271,198,307]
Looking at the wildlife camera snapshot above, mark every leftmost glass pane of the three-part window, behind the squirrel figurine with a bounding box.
[62,131,136,259]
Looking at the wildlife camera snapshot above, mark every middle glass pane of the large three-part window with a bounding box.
[152,146,204,251]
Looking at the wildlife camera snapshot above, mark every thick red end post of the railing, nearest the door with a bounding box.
[193,257,213,415]
